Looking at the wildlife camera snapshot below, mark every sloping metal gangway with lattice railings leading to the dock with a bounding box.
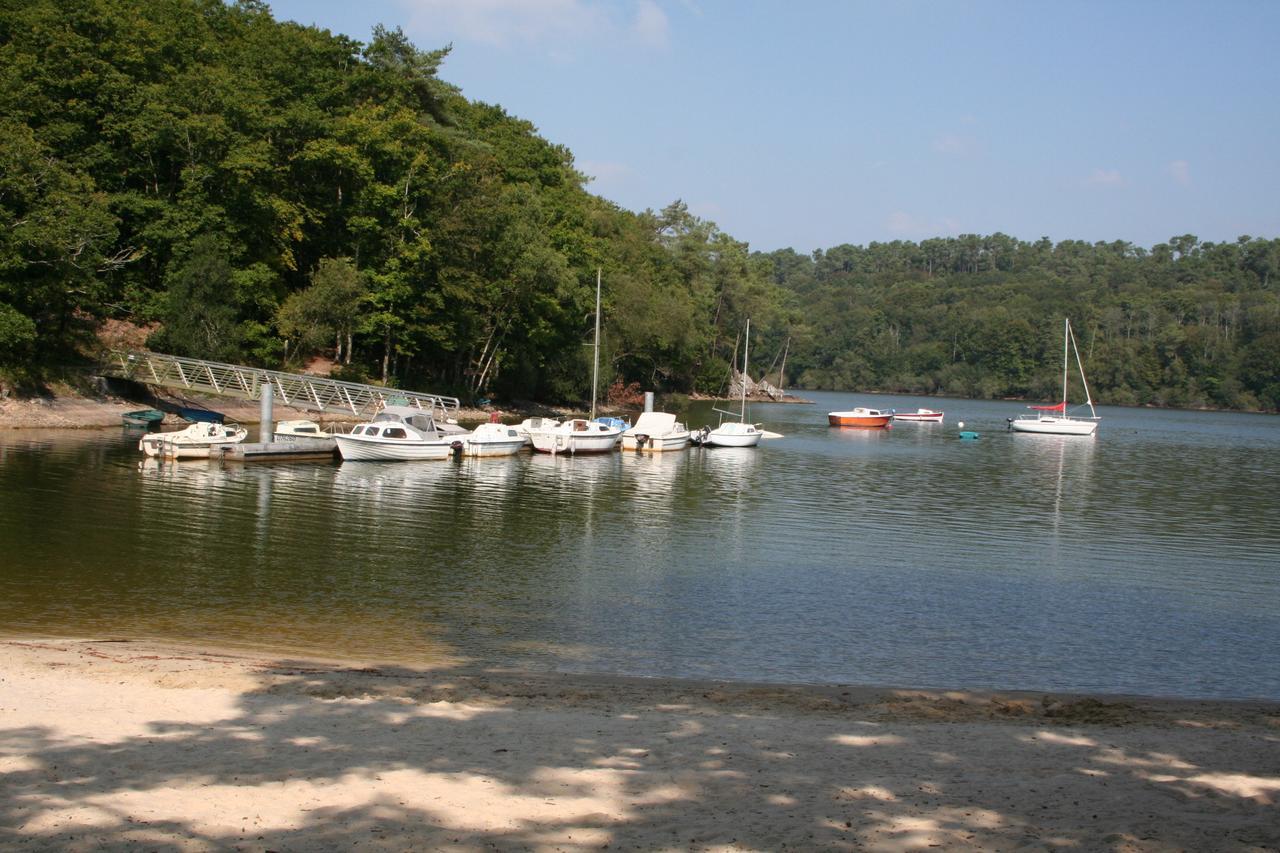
[102,350,460,423]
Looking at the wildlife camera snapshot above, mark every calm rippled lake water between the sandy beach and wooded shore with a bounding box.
[0,393,1280,699]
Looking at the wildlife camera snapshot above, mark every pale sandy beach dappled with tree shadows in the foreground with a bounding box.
[0,639,1280,850]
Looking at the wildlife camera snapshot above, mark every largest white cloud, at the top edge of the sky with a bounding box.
[399,0,669,54]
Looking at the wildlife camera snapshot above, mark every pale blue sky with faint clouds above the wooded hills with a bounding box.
[269,0,1280,254]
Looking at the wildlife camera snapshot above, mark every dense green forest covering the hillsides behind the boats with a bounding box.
[0,0,1280,410]
